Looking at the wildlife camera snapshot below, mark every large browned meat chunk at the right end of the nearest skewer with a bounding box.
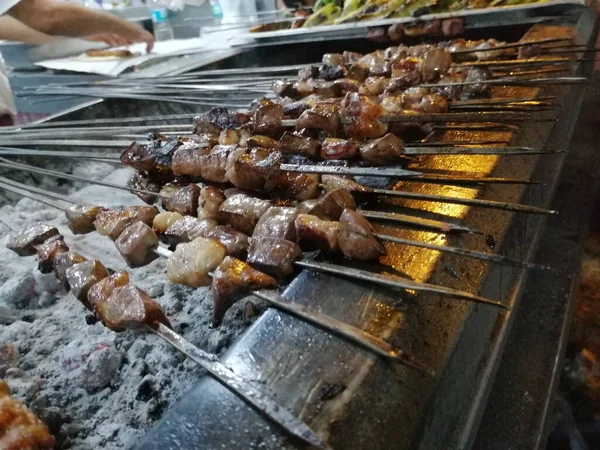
[96,283,171,332]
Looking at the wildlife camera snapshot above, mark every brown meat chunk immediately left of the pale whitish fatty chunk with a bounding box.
[115,222,158,268]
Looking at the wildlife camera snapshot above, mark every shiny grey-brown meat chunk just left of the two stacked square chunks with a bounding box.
[219,194,271,235]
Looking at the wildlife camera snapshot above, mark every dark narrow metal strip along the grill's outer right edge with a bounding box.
[473,76,600,450]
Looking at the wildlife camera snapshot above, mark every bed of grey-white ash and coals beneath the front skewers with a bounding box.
[0,163,264,450]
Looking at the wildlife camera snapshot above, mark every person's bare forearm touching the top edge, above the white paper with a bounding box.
[9,0,145,37]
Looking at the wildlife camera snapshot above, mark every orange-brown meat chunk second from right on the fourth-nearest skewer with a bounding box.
[295,214,340,252]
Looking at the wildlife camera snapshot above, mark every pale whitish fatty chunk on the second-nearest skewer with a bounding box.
[167,237,226,287]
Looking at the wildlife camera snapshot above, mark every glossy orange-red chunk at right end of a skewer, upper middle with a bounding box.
[342,92,388,140]
